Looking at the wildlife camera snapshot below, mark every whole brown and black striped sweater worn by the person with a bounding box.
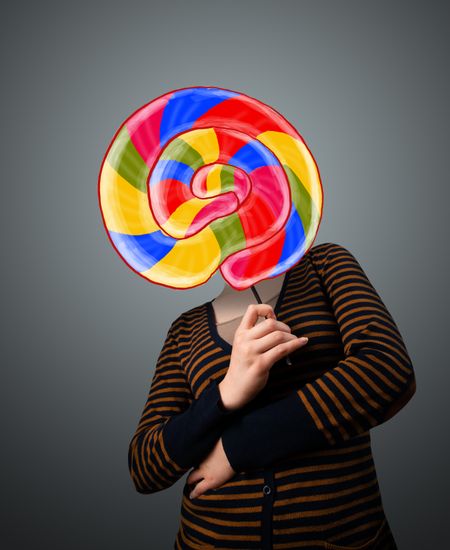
[128,243,416,550]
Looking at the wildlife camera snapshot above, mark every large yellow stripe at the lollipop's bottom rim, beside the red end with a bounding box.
[141,227,220,288]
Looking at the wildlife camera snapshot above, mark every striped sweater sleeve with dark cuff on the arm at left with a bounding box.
[128,323,236,494]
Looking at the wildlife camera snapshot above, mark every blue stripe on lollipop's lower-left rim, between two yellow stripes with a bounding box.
[109,230,177,272]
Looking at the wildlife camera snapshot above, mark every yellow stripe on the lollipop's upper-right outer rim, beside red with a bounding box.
[257,131,322,212]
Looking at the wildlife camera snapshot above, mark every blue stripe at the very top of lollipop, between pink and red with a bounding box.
[159,88,240,148]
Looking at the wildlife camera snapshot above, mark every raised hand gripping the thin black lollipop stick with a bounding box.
[219,304,308,410]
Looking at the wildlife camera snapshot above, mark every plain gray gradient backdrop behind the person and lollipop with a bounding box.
[0,1,450,550]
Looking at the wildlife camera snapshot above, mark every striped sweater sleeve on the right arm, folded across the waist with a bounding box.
[222,243,416,472]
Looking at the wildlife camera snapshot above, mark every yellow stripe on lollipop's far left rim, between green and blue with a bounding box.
[100,161,159,235]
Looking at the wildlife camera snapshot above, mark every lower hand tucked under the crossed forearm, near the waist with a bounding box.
[187,438,236,498]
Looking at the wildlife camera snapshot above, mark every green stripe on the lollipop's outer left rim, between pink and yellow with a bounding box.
[107,126,150,193]
